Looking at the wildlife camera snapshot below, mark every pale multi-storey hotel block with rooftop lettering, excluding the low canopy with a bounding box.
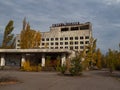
[16,22,92,51]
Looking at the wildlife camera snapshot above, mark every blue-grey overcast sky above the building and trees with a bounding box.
[0,0,120,52]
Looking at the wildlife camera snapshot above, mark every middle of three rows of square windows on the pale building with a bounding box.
[42,41,89,45]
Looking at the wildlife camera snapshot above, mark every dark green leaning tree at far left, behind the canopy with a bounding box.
[2,20,15,49]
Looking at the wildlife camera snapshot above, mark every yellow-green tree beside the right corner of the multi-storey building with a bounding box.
[80,37,97,70]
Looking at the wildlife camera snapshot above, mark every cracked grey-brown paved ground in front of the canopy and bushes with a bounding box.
[0,71,120,90]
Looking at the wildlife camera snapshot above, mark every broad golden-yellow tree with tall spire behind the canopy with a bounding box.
[20,19,41,49]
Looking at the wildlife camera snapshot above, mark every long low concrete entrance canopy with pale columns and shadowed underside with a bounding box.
[0,49,74,67]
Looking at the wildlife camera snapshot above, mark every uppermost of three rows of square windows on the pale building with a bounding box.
[42,36,89,41]
